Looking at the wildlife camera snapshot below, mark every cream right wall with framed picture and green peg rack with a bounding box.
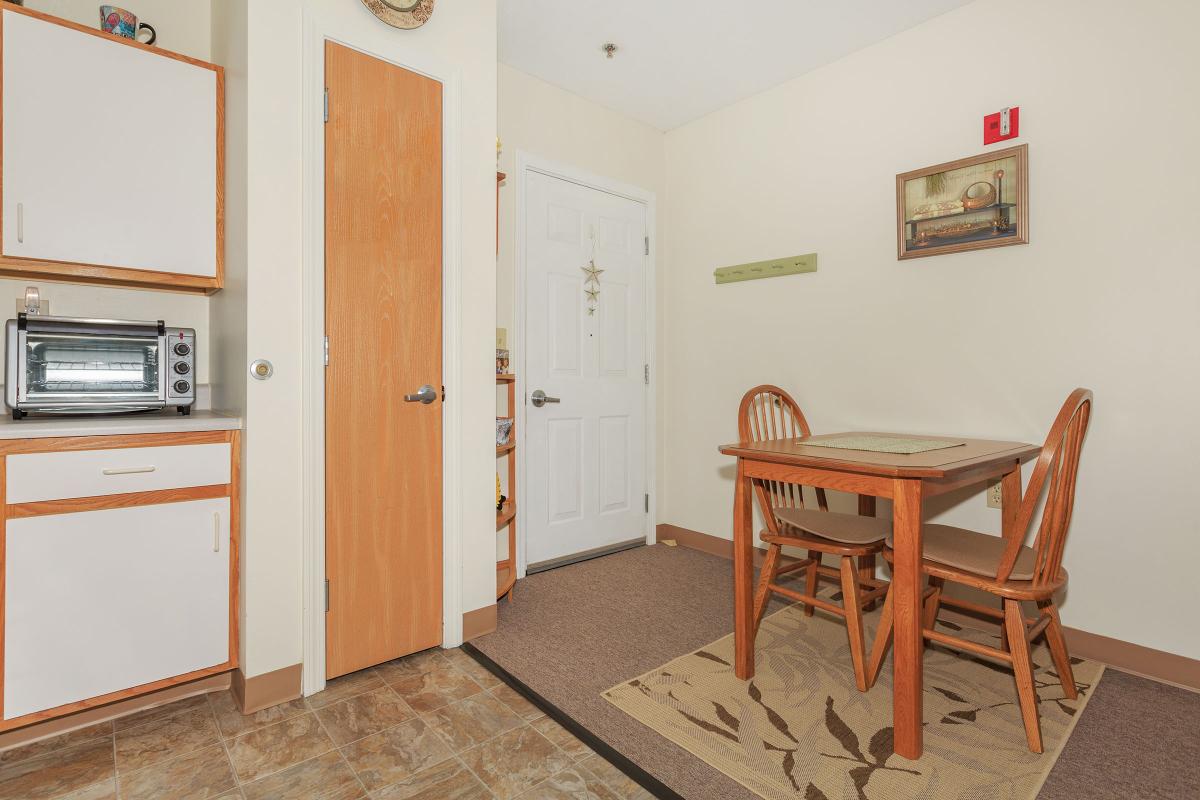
[660,0,1200,657]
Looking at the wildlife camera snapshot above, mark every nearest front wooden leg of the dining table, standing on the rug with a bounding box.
[892,479,924,758]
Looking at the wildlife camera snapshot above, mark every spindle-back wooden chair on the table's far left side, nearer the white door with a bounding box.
[738,385,892,691]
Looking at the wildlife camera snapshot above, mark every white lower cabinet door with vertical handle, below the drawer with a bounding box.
[4,498,230,720]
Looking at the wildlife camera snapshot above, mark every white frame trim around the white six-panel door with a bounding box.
[510,150,659,578]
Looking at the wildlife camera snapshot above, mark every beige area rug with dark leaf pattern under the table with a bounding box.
[604,606,1104,800]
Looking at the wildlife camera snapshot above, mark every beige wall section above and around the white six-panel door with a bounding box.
[496,64,666,558]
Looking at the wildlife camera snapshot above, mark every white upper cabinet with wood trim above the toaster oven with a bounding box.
[0,7,223,291]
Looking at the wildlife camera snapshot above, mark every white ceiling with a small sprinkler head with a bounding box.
[499,0,970,131]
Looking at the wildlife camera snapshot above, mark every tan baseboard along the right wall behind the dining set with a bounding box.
[658,524,1200,691]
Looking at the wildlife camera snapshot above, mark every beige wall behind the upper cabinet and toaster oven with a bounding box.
[7,0,211,384]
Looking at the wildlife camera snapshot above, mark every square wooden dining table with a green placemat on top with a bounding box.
[720,432,1042,759]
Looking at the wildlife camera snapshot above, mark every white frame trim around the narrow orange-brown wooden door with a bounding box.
[301,7,463,696]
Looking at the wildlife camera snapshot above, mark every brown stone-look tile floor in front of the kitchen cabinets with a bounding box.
[0,650,652,800]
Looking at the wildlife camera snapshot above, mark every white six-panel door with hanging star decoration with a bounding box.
[520,172,648,567]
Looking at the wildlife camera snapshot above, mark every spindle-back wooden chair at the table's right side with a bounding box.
[869,389,1092,753]
